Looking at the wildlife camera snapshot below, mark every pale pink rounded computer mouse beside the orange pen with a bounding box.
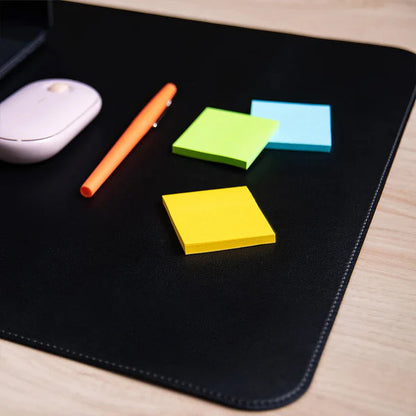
[0,79,102,163]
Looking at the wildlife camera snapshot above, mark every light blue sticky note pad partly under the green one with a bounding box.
[251,100,332,152]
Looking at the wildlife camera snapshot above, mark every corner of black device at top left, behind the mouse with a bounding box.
[0,0,52,78]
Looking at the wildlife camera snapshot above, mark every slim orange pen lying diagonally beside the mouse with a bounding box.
[80,83,176,198]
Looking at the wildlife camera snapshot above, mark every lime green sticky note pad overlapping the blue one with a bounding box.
[172,107,279,169]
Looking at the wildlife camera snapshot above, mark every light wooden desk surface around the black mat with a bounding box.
[0,0,416,416]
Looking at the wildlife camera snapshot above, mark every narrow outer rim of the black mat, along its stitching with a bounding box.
[0,86,416,410]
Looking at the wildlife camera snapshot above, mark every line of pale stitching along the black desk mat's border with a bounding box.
[0,87,416,408]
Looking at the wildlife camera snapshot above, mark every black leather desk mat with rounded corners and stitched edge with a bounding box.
[0,3,415,409]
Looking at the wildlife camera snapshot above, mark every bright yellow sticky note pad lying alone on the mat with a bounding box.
[162,186,276,254]
